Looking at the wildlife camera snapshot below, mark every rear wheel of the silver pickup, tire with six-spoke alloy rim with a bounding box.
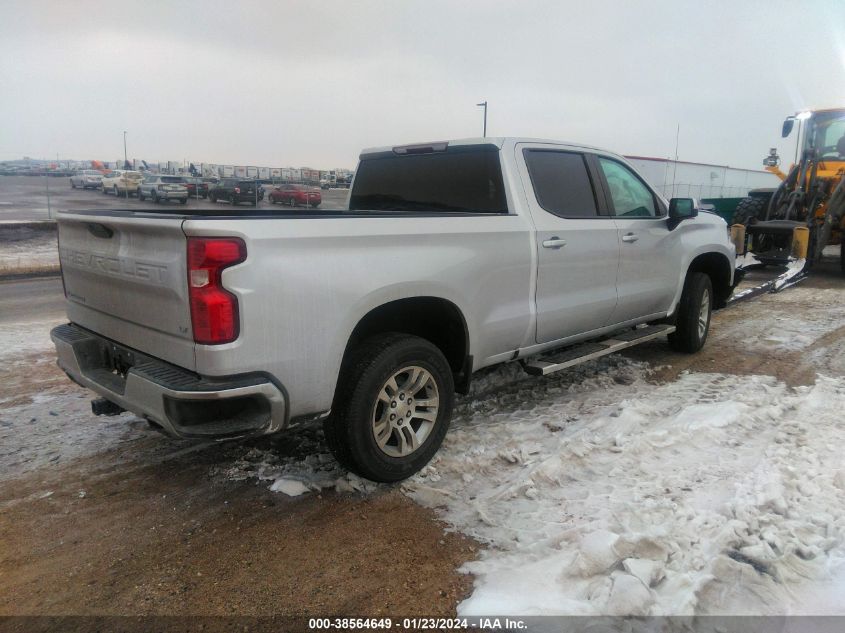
[323,333,455,482]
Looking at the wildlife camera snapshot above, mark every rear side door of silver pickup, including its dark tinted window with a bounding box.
[516,143,619,343]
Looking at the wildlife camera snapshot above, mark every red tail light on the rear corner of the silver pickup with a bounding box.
[188,237,246,345]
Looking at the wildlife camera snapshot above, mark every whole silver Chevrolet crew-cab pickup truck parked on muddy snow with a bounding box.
[52,138,734,481]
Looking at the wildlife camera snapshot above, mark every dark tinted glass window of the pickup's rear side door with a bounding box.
[523,149,597,218]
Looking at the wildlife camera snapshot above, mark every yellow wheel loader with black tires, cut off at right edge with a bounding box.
[732,108,845,282]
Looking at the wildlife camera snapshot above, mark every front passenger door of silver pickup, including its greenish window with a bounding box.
[595,156,682,323]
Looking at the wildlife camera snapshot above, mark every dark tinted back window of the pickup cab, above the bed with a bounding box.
[349,145,508,213]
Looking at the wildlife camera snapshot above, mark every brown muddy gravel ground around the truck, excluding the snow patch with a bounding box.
[0,256,845,616]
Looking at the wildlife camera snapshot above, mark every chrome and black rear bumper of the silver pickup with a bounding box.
[50,323,287,439]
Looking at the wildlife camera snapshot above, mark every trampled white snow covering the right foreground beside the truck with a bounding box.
[405,361,845,615]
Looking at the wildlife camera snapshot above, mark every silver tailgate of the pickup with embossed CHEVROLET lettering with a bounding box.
[58,212,195,370]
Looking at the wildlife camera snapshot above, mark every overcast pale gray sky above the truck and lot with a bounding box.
[0,0,845,168]
